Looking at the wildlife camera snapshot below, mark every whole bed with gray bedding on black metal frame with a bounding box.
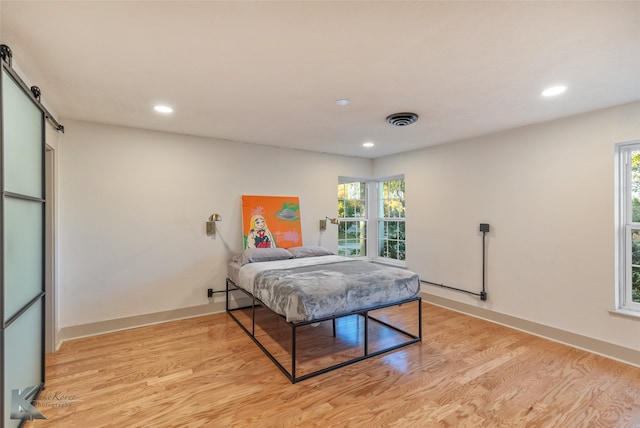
[226,246,422,383]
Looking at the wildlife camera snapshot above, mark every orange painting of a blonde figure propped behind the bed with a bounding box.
[242,195,302,248]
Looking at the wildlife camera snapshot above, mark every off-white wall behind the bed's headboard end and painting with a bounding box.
[58,120,372,328]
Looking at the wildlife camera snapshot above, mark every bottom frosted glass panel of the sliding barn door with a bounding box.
[2,303,42,427]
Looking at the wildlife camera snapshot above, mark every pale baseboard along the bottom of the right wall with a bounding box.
[421,292,640,367]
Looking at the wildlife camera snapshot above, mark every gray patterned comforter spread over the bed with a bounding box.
[238,256,420,322]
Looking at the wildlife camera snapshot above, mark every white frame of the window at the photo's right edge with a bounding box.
[615,141,640,316]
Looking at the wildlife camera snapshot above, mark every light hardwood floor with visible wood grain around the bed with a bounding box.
[26,303,640,428]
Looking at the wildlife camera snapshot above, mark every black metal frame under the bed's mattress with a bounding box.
[226,278,422,383]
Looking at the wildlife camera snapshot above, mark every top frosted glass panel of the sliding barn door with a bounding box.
[2,69,44,198]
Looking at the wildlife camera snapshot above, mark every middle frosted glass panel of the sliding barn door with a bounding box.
[3,197,44,320]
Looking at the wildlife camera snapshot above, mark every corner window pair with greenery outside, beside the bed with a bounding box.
[338,176,405,264]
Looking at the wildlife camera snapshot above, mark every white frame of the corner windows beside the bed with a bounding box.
[338,174,407,267]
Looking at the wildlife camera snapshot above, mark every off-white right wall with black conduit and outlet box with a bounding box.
[374,103,640,350]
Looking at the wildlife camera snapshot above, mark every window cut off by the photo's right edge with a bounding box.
[617,142,640,312]
